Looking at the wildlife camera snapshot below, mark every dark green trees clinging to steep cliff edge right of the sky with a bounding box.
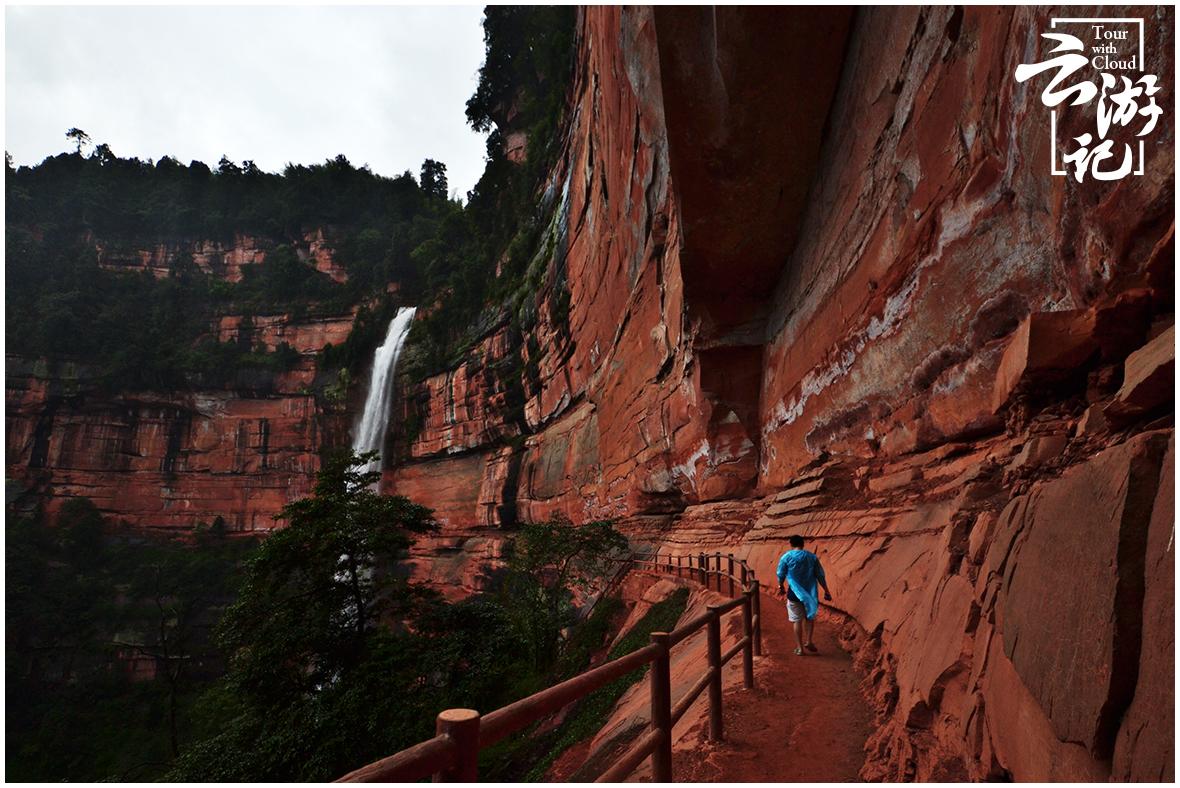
[406,6,577,379]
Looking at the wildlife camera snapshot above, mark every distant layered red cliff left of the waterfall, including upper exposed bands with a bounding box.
[5,232,355,531]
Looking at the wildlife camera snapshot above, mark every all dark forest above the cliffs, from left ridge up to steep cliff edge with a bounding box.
[5,7,575,390]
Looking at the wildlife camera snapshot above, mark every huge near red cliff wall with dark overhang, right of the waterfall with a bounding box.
[386,8,1174,780]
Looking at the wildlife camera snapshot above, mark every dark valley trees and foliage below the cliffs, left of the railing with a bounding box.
[6,455,646,781]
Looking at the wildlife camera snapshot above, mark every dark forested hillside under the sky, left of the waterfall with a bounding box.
[5,146,461,390]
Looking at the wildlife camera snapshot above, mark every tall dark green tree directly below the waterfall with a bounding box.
[170,453,437,780]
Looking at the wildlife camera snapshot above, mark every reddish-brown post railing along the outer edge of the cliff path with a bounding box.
[336,552,762,782]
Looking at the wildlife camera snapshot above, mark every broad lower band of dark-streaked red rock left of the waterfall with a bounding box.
[6,357,347,531]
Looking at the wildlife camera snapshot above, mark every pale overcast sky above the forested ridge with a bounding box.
[5,6,485,197]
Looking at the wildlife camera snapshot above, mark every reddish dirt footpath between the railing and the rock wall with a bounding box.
[673,593,872,782]
